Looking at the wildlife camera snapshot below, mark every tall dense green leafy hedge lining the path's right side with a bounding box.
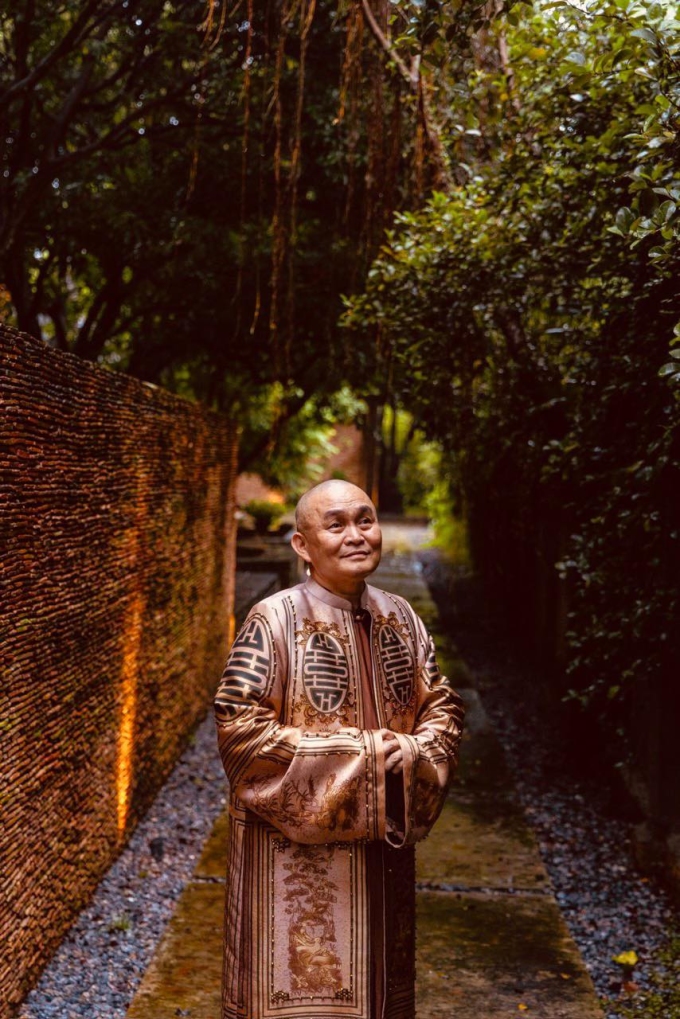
[346,0,680,758]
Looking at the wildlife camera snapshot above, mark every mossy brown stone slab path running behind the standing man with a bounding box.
[123,527,603,1019]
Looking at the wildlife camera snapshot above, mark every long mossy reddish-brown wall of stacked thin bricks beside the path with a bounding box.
[0,326,236,1016]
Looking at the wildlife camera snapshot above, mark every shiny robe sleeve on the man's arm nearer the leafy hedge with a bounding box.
[386,613,465,849]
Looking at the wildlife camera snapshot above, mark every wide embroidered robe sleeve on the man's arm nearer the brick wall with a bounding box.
[214,603,385,844]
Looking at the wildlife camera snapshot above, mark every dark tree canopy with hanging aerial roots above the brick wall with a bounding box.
[0,0,497,408]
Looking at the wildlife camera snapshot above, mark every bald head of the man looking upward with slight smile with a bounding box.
[293,481,382,598]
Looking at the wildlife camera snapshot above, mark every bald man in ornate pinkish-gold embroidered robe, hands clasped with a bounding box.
[215,481,463,1019]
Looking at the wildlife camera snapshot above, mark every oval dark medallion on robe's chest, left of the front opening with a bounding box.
[296,620,350,714]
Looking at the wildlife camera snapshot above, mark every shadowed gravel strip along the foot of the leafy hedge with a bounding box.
[419,549,680,1019]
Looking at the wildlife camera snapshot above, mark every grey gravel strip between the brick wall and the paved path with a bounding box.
[19,712,226,1019]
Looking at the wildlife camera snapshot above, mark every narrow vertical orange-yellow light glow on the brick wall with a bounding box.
[116,594,144,837]
